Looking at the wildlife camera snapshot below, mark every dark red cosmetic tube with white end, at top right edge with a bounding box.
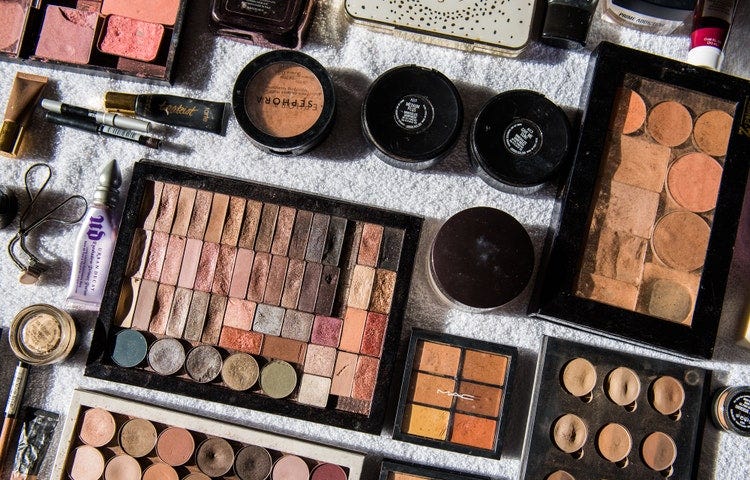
[687,0,737,69]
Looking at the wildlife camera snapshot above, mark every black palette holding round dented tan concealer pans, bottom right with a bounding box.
[522,337,710,480]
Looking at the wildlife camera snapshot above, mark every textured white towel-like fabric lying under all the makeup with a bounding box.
[0,0,750,480]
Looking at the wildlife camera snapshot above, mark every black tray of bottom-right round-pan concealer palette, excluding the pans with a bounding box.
[521,337,711,480]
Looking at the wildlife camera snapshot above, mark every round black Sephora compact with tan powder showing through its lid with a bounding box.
[232,50,336,155]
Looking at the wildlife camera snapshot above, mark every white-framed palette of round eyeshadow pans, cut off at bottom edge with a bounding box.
[51,391,365,480]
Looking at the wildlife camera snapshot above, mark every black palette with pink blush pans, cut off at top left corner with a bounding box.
[0,0,187,83]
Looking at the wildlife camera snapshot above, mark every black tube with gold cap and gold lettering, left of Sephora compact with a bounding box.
[104,92,228,135]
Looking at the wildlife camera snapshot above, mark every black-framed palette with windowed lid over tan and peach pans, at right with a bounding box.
[530,43,750,357]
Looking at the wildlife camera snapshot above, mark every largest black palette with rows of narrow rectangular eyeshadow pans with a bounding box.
[86,161,422,432]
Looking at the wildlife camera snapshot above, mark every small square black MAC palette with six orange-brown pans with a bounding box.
[393,329,518,457]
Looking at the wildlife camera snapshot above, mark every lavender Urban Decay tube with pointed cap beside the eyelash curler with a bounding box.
[67,160,122,310]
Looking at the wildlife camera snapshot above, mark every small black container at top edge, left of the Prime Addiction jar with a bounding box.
[541,2,596,48]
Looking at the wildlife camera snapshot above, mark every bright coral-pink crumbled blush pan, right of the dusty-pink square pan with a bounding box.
[99,15,164,62]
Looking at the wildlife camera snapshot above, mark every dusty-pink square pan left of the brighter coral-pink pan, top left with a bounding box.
[34,5,99,65]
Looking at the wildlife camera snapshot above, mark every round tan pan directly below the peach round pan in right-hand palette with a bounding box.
[651,211,711,272]
